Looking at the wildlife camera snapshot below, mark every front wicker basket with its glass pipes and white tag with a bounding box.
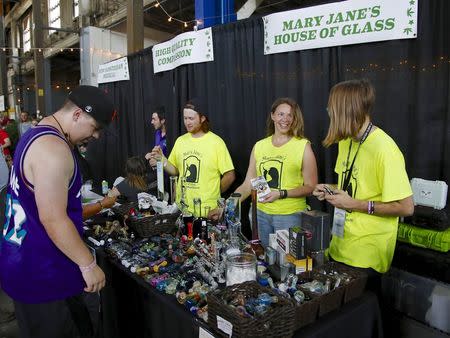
[207,281,295,338]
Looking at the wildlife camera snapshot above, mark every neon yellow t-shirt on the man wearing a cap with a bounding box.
[168,132,234,215]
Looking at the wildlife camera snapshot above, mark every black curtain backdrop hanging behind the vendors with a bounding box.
[87,0,450,210]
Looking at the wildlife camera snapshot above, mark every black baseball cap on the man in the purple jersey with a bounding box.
[68,86,115,128]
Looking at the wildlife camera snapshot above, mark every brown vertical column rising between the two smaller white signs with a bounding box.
[127,0,144,54]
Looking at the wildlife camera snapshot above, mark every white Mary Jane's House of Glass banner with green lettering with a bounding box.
[263,0,418,54]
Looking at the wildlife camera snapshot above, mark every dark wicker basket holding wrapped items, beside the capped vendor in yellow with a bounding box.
[114,202,180,237]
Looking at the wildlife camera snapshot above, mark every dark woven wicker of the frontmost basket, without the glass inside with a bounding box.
[207,281,295,338]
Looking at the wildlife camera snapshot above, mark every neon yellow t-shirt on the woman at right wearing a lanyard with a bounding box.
[330,128,412,273]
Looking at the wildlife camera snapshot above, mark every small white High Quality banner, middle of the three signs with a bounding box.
[152,27,214,73]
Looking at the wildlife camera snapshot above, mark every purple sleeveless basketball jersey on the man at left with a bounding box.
[0,126,85,303]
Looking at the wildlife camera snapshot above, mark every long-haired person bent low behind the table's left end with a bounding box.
[108,156,156,202]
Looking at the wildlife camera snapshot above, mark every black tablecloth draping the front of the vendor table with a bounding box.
[97,249,382,338]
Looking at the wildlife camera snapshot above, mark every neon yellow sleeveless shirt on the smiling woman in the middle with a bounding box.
[254,136,308,215]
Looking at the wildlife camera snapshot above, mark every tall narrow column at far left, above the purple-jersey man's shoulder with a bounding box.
[32,0,47,116]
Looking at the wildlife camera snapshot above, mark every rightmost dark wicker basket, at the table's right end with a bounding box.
[323,262,367,304]
